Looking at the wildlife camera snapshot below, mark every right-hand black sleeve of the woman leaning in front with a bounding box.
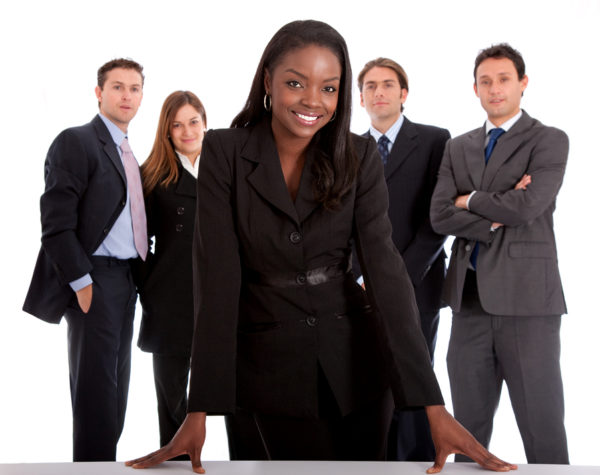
[354,141,443,407]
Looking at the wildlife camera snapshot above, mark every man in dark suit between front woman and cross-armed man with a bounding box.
[353,58,450,461]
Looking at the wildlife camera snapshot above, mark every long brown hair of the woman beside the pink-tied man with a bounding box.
[142,91,206,195]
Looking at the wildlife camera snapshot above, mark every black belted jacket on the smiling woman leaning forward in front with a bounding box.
[188,121,442,417]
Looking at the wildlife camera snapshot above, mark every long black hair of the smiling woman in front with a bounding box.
[231,20,359,209]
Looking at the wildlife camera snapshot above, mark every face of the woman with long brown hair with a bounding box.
[169,104,205,163]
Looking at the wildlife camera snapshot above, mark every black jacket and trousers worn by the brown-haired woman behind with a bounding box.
[138,163,196,445]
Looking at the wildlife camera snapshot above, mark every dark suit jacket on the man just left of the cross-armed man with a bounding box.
[353,117,450,312]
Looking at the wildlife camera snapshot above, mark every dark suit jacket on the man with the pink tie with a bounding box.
[23,116,127,323]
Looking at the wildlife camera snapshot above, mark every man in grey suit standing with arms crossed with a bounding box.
[431,44,569,464]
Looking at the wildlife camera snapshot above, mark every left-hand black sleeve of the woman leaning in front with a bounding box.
[188,131,241,414]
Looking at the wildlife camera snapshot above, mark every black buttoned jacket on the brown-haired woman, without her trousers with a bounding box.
[138,163,196,354]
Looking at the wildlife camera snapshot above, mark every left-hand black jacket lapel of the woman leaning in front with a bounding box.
[241,120,306,224]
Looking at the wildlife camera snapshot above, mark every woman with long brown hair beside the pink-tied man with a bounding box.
[138,91,206,452]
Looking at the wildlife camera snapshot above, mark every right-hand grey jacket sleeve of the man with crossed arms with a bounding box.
[469,127,569,226]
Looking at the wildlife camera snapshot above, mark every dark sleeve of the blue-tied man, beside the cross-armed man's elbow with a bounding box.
[402,129,450,286]
